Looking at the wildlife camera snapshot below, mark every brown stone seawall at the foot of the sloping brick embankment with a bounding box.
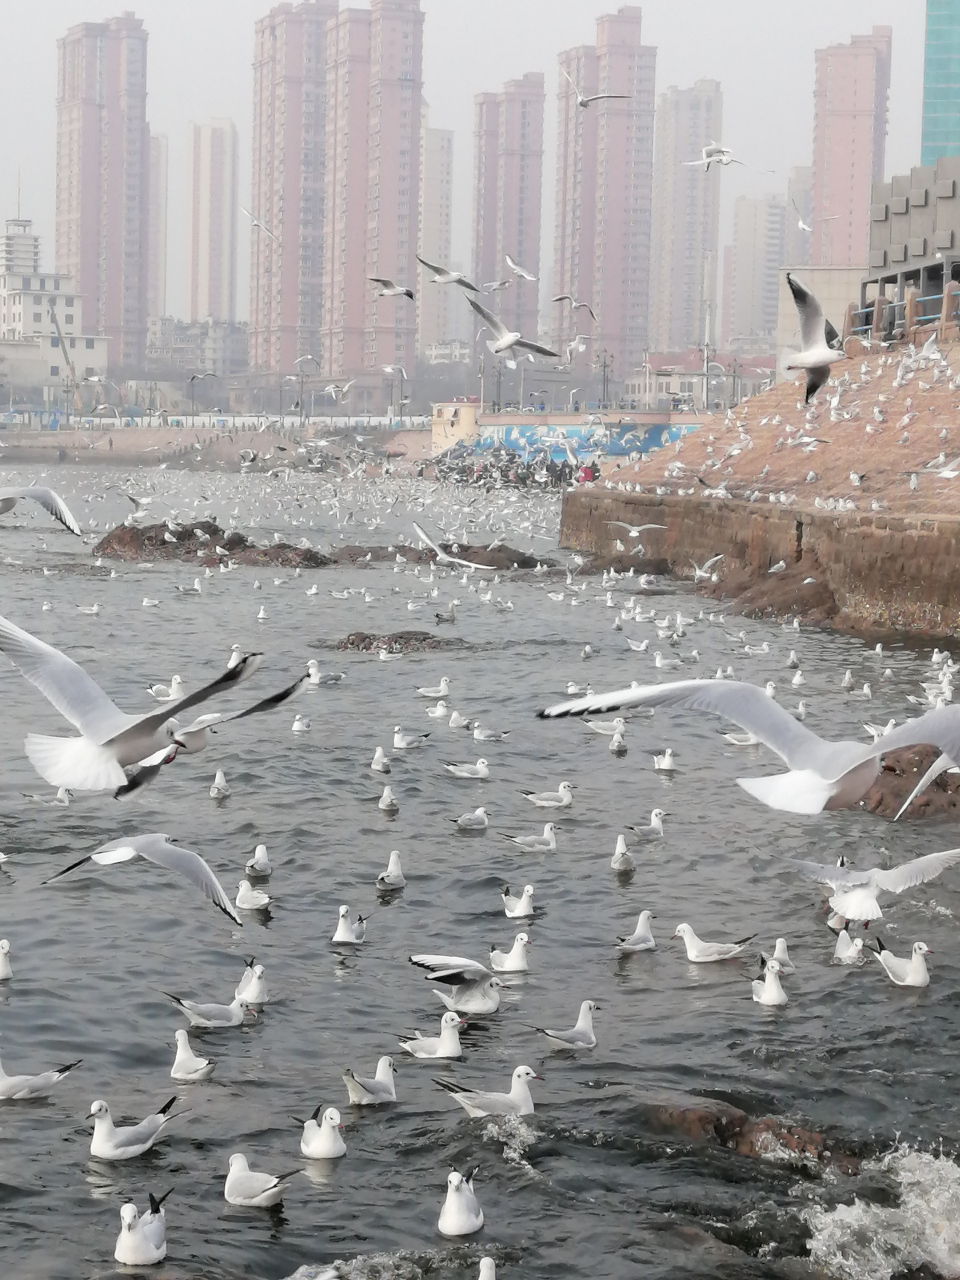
[561,488,960,636]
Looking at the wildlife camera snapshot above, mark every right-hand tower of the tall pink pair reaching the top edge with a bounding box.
[321,0,424,378]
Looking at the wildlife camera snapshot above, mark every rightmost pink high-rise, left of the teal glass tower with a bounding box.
[810,27,893,266]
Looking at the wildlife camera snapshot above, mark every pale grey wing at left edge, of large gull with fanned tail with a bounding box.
[0,617,129,742]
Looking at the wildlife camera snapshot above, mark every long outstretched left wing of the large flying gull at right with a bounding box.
[540,680,874,777]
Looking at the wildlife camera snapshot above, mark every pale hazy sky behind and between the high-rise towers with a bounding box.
[0,0,925,317]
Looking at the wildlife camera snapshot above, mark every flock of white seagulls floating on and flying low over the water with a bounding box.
[0,455,960,1280]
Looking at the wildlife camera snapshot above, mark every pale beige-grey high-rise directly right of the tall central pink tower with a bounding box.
[650,79,723,351]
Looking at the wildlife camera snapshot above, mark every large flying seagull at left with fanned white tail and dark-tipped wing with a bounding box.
[0,618,262,791]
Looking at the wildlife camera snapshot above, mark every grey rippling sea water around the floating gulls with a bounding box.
[0,472,960,1280]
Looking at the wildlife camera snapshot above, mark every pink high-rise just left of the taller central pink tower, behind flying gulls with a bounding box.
[472,72,545,339]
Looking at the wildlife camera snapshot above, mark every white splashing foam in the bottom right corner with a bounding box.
[803,1146,960,1280]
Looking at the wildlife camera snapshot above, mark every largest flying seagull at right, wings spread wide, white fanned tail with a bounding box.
[540,680,960,813]
